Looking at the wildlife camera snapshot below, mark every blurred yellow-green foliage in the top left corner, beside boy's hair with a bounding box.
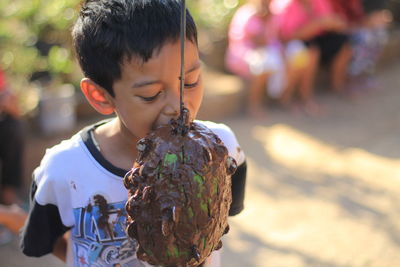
[0,0,80,79]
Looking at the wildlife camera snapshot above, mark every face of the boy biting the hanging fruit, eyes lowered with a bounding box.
[112,41,203,139]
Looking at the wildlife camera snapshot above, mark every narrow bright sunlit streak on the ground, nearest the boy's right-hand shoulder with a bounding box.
[253,125,400,190]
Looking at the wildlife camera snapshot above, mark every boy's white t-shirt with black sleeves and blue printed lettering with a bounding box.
[22,121,245,267]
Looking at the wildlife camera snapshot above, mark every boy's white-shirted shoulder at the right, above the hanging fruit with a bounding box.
[195,120,245,165]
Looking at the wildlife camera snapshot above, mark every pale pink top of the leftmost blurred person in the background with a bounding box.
[225,4,278,77]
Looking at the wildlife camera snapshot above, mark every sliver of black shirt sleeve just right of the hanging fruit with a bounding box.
[229,161,247,216]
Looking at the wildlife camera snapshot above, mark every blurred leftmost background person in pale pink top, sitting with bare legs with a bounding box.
[225,0,308,118]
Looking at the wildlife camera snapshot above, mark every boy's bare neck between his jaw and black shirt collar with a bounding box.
[94,118,138,170]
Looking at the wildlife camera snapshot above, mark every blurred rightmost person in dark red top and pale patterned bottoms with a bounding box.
[331,0,392,93]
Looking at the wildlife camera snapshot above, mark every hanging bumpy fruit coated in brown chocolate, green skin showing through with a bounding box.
[124,110,236,267]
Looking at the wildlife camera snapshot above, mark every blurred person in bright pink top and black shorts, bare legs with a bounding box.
[280,0,352,112]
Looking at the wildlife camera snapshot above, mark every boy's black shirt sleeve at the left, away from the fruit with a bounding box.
[20,182,69,257]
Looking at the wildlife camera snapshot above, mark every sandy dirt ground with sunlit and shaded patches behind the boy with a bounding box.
[0,61,400,267]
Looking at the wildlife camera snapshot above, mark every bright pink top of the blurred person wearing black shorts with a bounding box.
[280,0,334,39]
